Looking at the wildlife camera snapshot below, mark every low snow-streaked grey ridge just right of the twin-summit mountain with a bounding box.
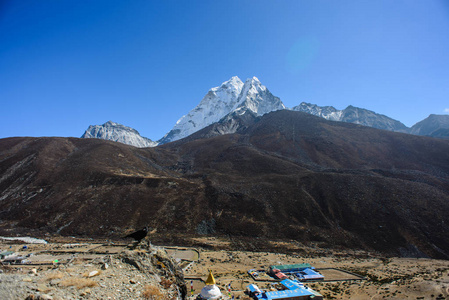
[292,102,408,132]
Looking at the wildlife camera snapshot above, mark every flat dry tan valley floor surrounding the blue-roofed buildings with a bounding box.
[185,238,449,299]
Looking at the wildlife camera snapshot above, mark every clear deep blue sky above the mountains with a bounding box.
[0,0,449,140]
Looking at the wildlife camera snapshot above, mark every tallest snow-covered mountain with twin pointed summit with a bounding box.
[159,76,285,144]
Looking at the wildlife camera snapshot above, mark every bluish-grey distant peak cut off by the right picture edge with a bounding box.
[410,115,449,138]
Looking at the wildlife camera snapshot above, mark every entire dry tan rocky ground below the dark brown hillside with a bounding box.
[0,238,449,300]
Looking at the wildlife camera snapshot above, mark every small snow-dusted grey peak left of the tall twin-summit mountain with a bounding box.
[81,121,157,148]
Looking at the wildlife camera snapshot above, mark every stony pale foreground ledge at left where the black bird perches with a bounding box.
[0,242,185,300]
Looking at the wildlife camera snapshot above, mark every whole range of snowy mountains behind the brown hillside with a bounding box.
[82,76,449,147]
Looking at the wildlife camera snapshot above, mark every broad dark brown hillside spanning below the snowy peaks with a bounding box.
[0,111,449,259]
